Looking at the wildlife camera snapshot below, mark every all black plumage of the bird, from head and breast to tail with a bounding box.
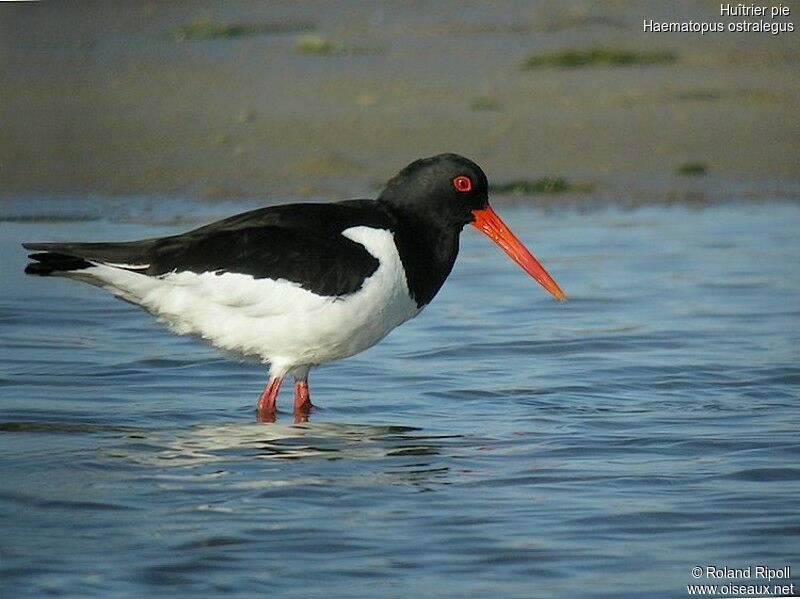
[23,154,488,307]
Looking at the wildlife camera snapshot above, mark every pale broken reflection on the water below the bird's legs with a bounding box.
[83,422,468,500]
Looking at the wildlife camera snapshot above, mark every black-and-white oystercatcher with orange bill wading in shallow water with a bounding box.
[22,153,566,422]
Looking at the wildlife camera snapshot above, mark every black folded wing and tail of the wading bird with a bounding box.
[23,200,395,296]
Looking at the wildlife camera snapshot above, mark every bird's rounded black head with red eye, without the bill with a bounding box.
[378,154,489,226]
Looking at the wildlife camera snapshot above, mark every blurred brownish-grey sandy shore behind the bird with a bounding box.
[0,0,800,197]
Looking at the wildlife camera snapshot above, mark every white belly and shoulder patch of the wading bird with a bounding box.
[82,226,420,376]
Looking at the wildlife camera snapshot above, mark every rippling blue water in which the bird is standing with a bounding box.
[0,198,800,597]
